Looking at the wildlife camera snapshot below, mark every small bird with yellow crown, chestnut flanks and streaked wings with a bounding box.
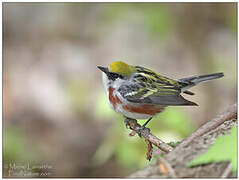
[97,61,224,129]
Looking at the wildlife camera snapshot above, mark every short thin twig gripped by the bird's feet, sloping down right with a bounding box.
[125,117,173,153]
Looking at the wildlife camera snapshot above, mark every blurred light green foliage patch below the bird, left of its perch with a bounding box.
[93,113,146,170]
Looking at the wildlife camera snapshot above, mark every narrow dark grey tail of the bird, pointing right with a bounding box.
[178,73,224,92]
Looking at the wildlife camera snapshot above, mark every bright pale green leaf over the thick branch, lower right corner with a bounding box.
[188,126,237,172]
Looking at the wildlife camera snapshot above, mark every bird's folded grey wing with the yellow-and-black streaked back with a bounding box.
[118,66,197,106]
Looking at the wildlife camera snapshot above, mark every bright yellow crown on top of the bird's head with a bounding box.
[109,61,136,76]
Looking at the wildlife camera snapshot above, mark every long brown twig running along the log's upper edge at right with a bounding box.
[176,104,237,148]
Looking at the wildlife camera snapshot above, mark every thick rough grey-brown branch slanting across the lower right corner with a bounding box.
[130,104,237,178]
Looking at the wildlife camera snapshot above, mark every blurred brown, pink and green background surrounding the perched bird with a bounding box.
[3,3,237,177]
